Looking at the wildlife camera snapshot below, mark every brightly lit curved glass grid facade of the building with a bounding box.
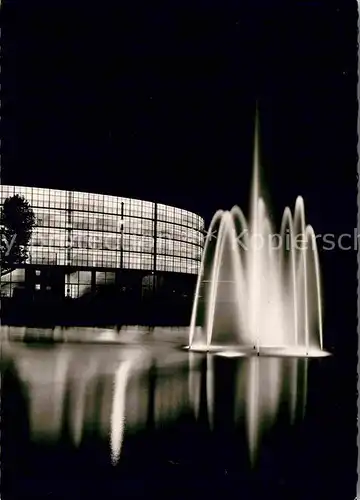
[1,186,204,297]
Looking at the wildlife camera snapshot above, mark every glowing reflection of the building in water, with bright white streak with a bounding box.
[9,346,194,462]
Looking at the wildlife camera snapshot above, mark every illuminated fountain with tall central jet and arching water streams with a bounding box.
[189,116,328,357]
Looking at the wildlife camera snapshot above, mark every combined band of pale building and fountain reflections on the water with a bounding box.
[1,328,308,465]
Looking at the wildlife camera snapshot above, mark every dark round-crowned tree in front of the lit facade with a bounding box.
[0,194,36,276]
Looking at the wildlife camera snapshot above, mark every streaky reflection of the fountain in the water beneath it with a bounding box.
[189,353,308,461]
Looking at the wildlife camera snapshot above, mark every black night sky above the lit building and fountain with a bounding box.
[2,0,357,336]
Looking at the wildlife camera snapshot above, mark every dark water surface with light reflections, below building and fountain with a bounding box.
[2,328,357,500]
